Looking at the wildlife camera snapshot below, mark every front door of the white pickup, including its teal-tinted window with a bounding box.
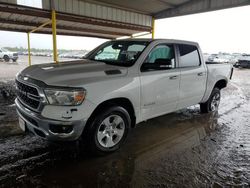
[140,44,180,120]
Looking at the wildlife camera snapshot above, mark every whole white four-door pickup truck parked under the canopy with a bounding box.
[15,39,233,153]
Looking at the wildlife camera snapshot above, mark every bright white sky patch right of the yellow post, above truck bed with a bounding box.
[155,6,250,53]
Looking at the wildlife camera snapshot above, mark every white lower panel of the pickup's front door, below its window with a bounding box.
[140,69,180,119]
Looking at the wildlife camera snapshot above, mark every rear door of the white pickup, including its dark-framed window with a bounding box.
[177,44,207,109]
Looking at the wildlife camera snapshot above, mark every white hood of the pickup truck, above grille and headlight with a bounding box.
[21,60,128,87]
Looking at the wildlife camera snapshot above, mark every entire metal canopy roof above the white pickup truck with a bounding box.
[0,0,250,39]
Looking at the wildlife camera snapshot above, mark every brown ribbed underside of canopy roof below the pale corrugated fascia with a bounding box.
[0,3,151,39]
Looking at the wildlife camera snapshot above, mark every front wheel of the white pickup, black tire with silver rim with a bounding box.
[83,106,131,155]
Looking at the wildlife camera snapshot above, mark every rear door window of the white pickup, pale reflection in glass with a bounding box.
[179,44,200,67]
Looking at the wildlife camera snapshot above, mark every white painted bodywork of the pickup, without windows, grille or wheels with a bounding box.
[19,39,231,123]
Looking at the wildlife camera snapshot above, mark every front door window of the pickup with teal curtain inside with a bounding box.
[141,44,175,72]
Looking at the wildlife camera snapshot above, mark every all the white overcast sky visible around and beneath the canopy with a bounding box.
[0,0,250,53]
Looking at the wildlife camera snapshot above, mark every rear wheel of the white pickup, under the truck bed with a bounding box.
[200,88,221,113]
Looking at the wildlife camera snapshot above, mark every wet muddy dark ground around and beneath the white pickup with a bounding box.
[0,66,250,188]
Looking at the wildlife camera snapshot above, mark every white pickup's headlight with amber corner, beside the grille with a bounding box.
[44,89,86,106]
